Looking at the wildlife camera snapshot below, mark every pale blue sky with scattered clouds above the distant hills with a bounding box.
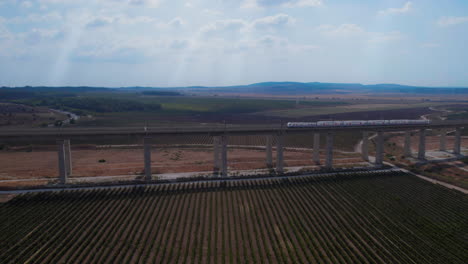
[0,0,468,87]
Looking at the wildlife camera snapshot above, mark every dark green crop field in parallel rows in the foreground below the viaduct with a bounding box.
[0,171,468,263]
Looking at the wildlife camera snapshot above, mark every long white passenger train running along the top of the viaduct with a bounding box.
[287,119,431,128]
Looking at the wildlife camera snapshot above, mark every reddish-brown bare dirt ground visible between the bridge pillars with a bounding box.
[0,145,362,186]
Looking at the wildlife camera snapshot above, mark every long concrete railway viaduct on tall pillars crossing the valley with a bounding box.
[0,120,468,184]
